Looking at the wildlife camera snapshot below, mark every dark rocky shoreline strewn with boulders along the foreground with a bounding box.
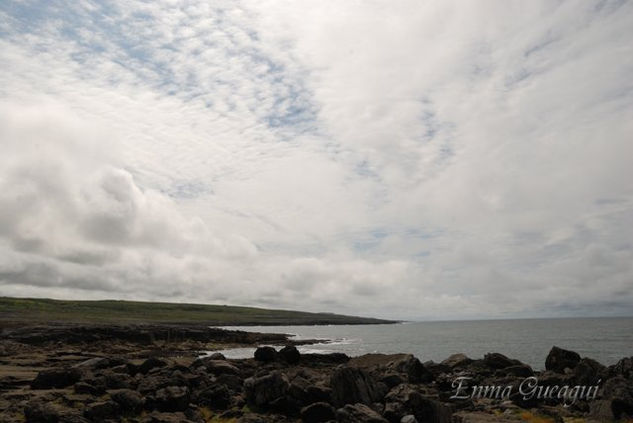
[0,324,633,423]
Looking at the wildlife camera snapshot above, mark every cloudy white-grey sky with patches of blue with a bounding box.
[0,0,633,320]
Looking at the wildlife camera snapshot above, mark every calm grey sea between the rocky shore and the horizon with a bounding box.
[214,317,633,370]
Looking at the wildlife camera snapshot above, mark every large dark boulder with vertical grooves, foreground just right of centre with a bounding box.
[330,366,387,407]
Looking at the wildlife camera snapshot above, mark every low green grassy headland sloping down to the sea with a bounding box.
[0,297,395,326]
